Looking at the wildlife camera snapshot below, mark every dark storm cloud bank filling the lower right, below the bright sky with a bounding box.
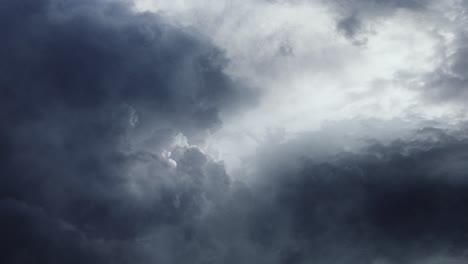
[134,125,468,264]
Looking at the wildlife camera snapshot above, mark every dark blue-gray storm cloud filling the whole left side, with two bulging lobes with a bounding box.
[0,0,249,263]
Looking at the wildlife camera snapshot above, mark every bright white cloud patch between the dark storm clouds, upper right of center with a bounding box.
[136,0,466,171]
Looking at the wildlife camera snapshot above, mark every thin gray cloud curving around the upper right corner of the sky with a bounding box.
[332,1,468,106]
